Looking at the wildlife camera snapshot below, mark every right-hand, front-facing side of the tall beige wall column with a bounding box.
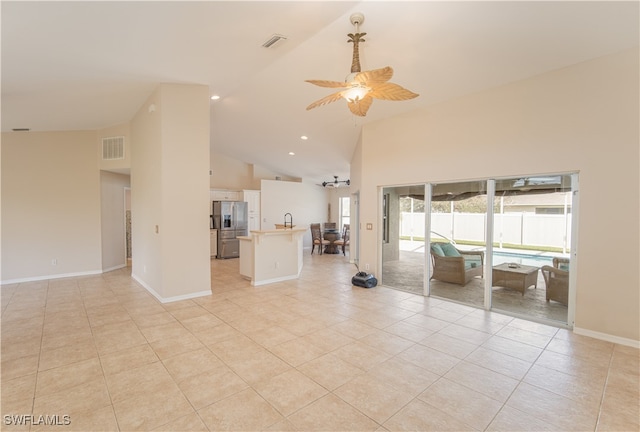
[161,84,211,298]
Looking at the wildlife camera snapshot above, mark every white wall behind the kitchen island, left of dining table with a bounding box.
[260,180,329,249]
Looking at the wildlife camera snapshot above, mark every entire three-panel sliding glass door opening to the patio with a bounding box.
[381,174,577,324]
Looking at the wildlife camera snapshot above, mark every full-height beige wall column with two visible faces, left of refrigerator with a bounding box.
[131,84,211,301]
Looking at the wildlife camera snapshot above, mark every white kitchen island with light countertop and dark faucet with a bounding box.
[238,227,309,286]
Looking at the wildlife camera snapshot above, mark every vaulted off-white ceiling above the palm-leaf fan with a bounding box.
[1,1,639,183]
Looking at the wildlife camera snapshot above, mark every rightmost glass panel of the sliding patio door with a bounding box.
[491,175,572,323]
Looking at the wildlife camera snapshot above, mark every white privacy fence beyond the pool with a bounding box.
[400,212,571,250]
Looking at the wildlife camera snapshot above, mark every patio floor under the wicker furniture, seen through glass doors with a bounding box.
[381,243,567,324]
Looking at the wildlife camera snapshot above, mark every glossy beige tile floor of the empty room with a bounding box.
[1,254,640,431]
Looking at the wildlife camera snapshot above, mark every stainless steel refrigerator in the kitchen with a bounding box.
[213,201,248,259]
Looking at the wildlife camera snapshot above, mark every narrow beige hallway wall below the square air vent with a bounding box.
[100,171,130,271]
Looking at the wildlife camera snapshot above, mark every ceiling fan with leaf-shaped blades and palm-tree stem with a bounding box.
[306,13,419,117]
